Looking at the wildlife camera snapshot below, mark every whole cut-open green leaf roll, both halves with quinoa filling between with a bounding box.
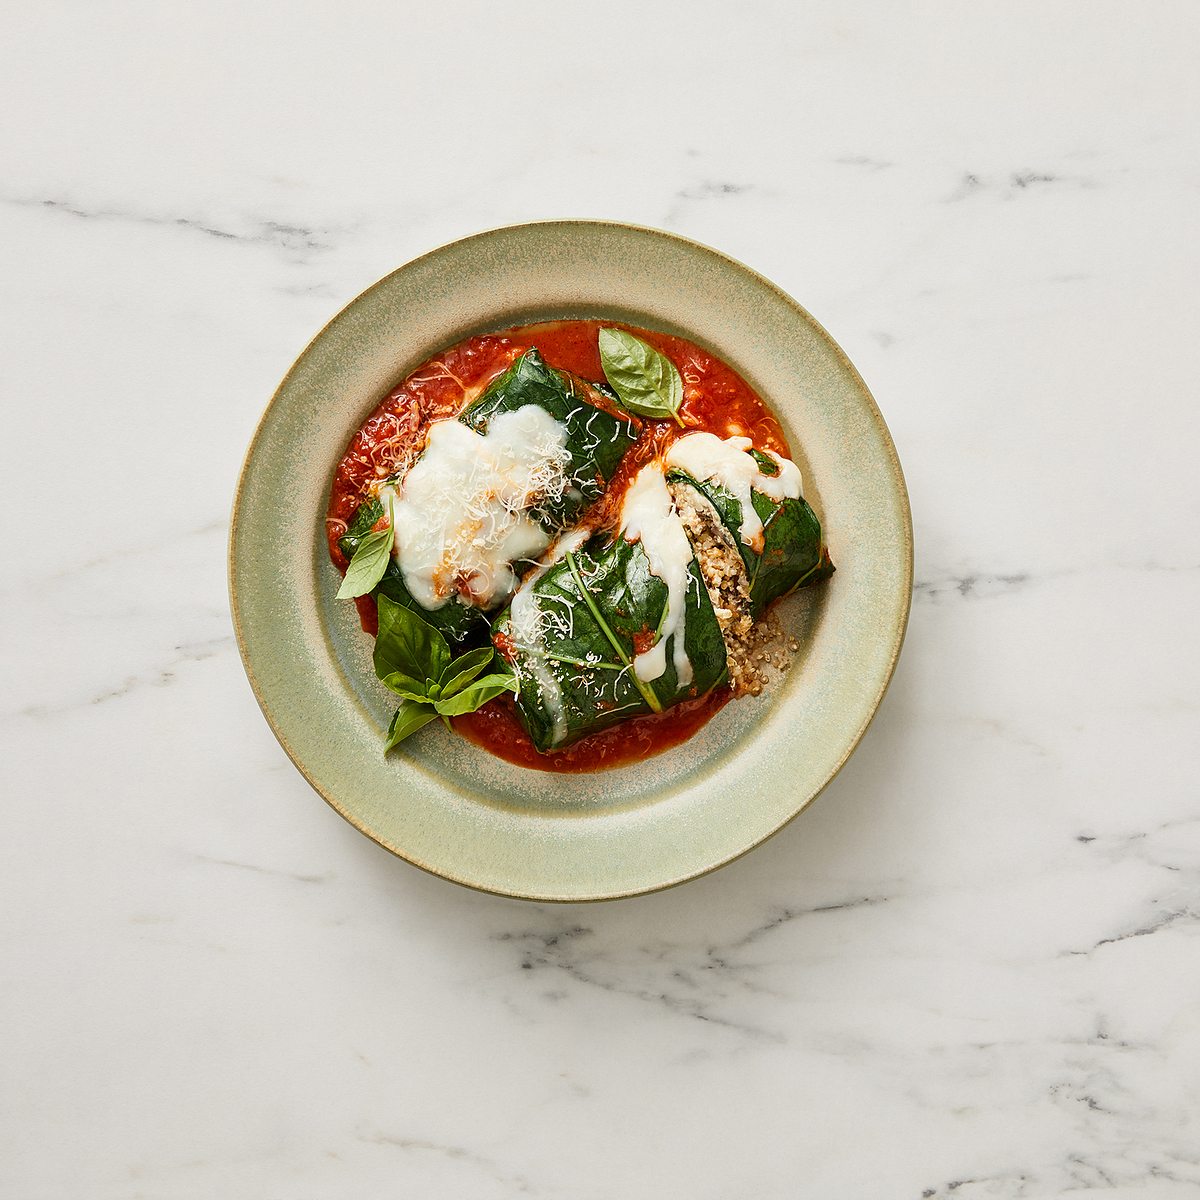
[493,433,833,754]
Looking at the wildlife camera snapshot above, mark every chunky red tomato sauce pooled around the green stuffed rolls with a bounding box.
[325,320,791,773]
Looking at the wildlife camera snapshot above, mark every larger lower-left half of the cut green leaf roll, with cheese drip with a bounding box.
[493,463,726,754]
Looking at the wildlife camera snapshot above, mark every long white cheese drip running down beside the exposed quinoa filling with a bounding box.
[620,463,692,688]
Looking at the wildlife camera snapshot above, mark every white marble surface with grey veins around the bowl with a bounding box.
[0,0,1200,1200]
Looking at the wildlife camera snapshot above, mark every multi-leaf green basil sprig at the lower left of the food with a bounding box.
[374,592,517,754]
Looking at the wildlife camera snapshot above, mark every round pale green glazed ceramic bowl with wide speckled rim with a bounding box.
[229,221,912,900]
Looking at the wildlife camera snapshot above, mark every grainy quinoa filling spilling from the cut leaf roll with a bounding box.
[667,482,798,696]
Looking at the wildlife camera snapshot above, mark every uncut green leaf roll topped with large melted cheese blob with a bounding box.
[338,349,638,644]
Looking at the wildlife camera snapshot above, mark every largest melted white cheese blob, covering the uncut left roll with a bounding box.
[378,404,570,608]
